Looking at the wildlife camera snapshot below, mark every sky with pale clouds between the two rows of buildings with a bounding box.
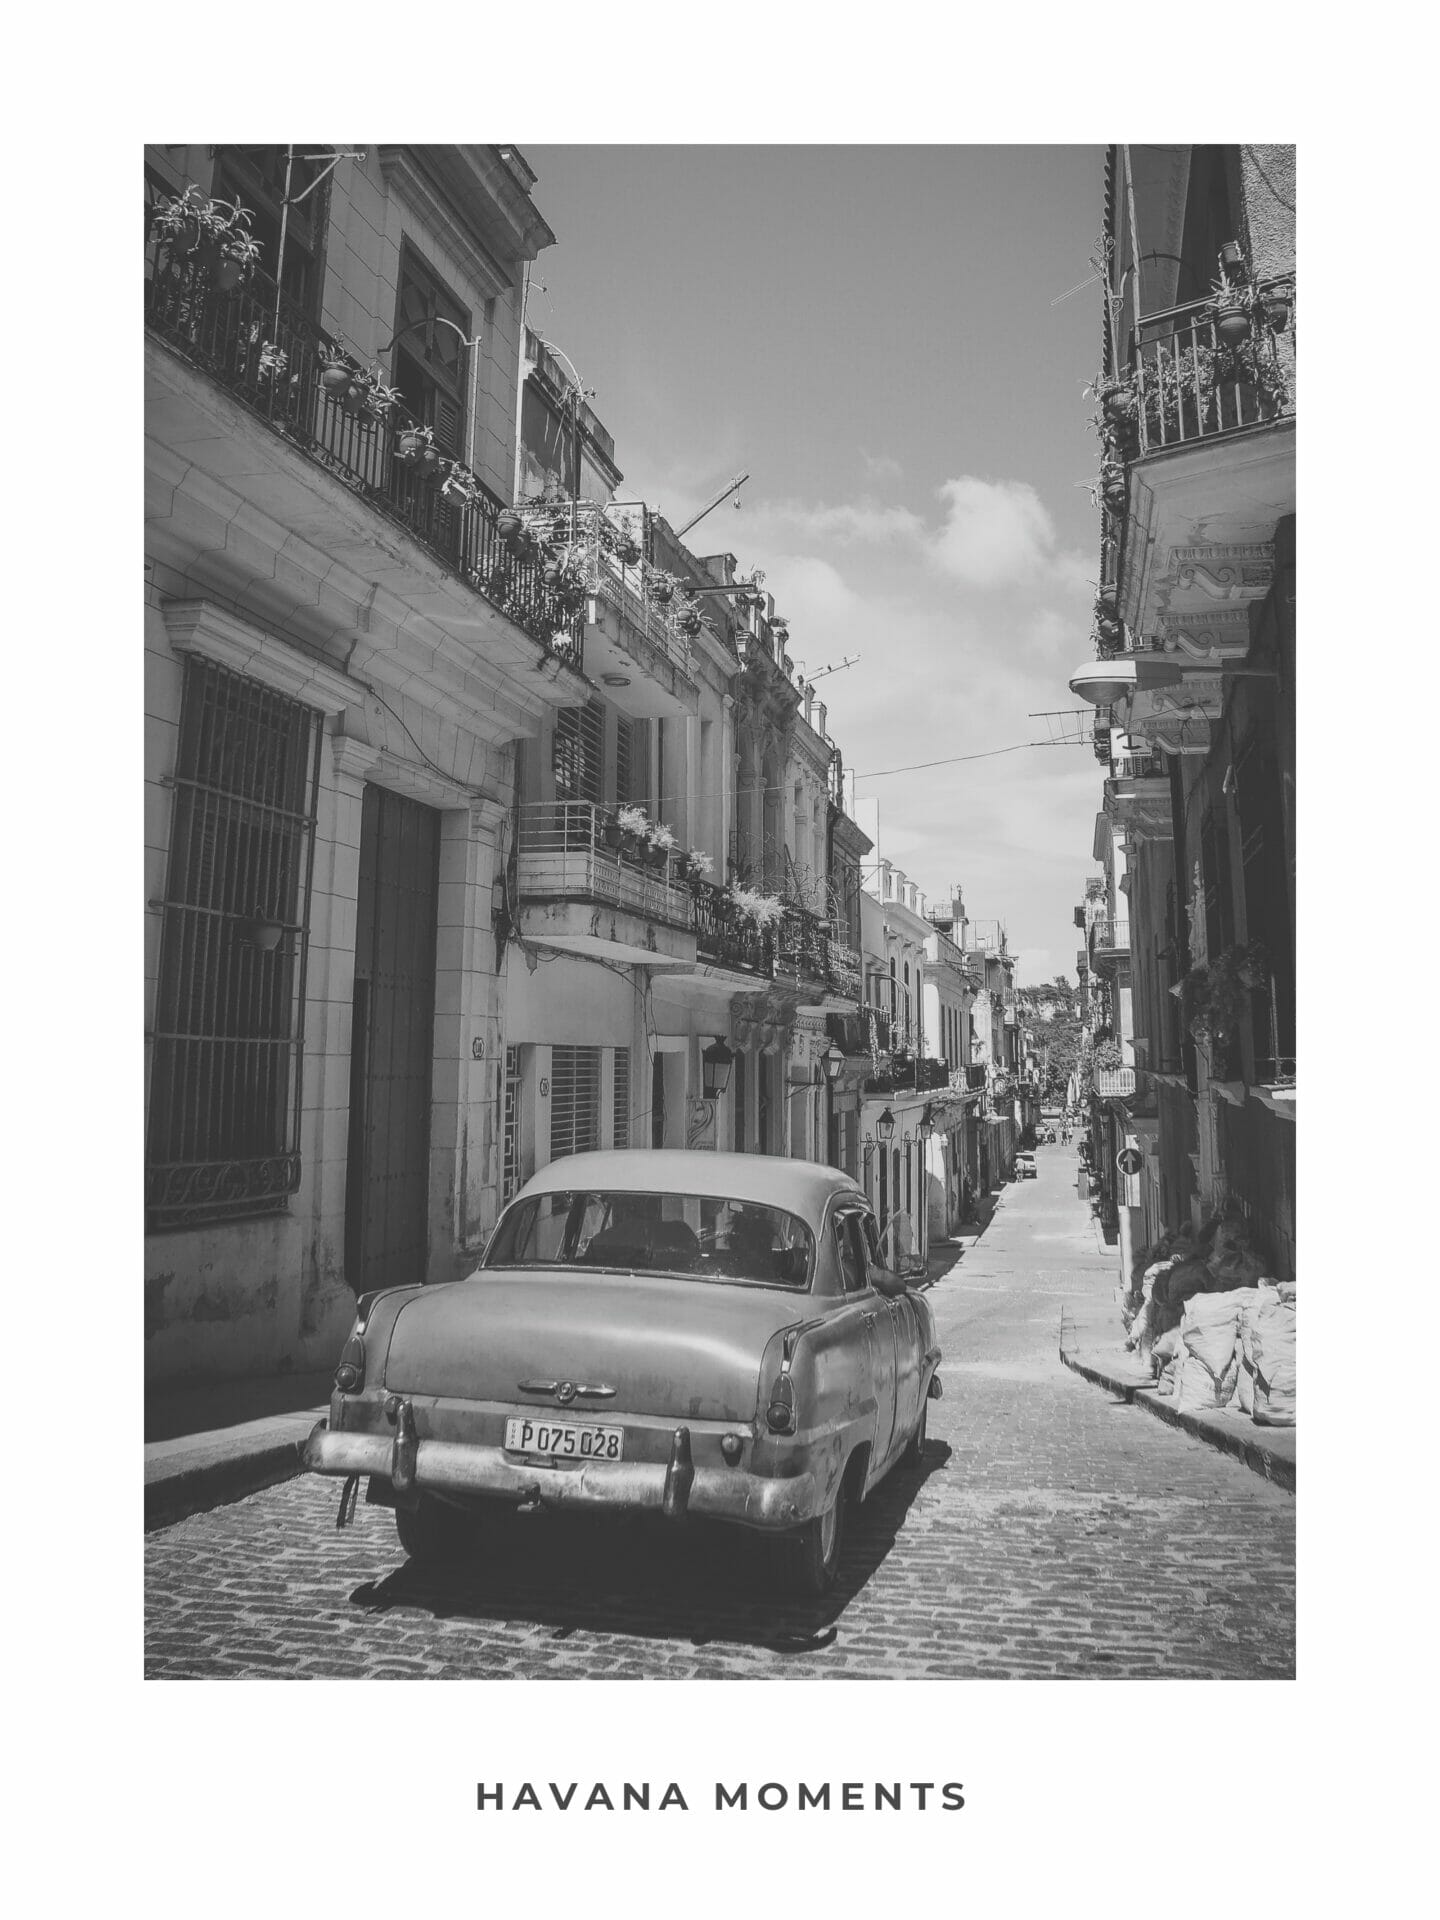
[524,146,1104,983]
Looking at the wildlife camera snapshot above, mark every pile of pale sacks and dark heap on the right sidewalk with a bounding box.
[1121,1215,1296,1427]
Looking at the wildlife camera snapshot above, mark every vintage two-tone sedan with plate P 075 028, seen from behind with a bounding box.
[305,1150,941,1594]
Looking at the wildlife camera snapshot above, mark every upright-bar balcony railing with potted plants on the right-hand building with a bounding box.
[1129,282,1292,453]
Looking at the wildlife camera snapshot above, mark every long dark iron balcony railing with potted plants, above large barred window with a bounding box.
[146,238,584,670]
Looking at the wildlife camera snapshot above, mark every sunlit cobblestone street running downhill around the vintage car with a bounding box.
[146,1146,1296,1680]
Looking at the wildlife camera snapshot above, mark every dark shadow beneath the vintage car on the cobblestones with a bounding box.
[349,1440,950,1653]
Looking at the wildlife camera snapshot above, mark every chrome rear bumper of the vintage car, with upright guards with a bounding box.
[303,1419,820,1528]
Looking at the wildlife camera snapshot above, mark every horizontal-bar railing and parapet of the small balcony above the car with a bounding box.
[516,801,695,931]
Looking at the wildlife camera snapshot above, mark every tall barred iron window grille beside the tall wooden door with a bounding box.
[146,660,324,1233]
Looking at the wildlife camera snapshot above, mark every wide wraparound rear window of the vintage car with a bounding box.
[482,1190,814,1288]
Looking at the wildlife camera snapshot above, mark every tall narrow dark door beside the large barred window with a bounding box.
[346,785,440,1294]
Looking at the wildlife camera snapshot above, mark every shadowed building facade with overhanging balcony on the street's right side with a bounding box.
[1071,146,1296,1281]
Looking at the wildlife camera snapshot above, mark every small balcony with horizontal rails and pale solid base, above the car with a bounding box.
[516,801,695,968]
